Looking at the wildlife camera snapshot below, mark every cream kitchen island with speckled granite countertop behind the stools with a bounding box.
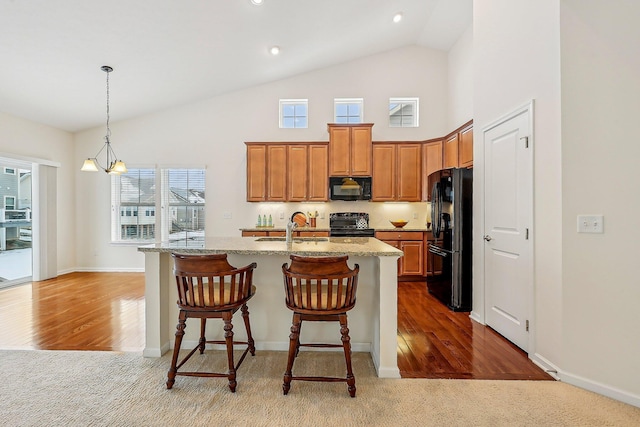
[138,237,402,378]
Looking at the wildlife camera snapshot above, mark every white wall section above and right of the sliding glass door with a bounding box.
[0,113,76,273]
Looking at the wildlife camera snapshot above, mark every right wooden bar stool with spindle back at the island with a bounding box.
[282,255,360,397]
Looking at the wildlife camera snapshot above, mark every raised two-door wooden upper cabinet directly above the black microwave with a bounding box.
[327,123,373,176]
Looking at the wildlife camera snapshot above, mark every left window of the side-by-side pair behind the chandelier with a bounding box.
[111,169,156,242]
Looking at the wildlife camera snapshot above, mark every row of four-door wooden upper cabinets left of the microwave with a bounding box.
[246,142,329,202]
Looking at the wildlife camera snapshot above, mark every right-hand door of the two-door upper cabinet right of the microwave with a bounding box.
[396,144,422,202]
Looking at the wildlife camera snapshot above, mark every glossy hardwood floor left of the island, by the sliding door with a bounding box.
[0,273,145,351]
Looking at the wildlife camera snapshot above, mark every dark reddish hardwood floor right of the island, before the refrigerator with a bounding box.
[398,282,553,380]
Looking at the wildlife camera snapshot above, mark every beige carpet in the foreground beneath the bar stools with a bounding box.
[0,351,640,426]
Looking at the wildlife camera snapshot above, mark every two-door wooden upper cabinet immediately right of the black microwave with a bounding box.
[372,143,423,202]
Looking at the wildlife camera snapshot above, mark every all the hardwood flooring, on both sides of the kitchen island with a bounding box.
[0,273,552,379]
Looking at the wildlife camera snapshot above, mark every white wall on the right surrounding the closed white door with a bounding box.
[473,0,640,406]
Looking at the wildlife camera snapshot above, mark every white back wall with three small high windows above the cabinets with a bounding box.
[76,46,450,270]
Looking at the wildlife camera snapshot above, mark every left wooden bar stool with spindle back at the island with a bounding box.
[167,254,257,392]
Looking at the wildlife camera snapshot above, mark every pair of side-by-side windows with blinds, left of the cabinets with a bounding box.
[111,168,205,243]
